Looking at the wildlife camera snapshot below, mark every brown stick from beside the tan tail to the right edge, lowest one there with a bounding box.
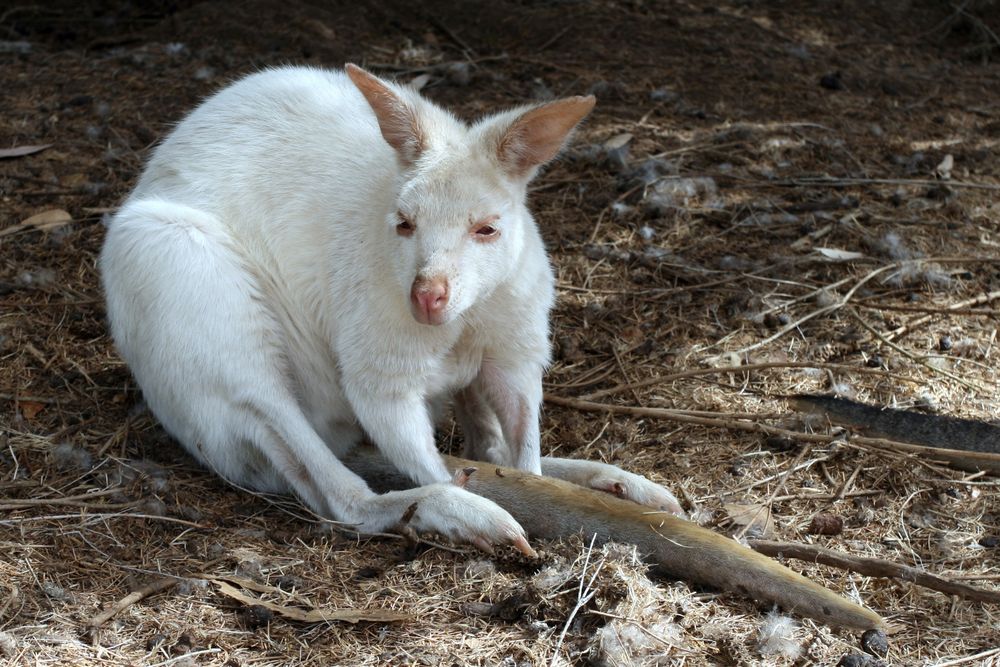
[749,540,1000,604]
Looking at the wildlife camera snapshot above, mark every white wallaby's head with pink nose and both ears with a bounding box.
[347,65,594,325]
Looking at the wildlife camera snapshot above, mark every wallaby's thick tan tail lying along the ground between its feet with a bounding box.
[343,447,886,630]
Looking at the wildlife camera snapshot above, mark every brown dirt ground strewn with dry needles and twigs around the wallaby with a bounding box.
[0,0,1000,667]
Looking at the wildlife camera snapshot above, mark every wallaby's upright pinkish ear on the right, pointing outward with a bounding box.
[497,95,596,178]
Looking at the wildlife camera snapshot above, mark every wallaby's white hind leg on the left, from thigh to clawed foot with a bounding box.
[101,200,531,552]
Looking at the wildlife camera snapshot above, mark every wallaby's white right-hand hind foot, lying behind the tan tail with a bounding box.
[542,456,686,517]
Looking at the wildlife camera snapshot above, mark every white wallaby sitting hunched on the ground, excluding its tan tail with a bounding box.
[100,65,680,553]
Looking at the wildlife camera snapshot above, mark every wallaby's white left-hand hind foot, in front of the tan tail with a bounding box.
[358,480,537,558]
